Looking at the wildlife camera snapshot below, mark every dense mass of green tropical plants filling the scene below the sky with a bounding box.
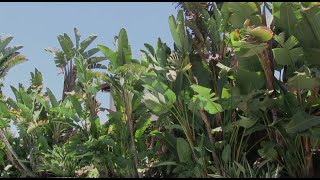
[0,2,320,178]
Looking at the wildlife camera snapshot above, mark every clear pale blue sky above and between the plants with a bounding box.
[0,2,177,112]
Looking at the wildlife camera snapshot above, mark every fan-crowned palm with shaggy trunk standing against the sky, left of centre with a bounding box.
[45,28,107,143]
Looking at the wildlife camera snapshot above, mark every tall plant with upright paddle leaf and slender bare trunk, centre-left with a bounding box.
[98,29,148,177]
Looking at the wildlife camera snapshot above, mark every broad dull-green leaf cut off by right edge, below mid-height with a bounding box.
[285,111,320,134]
